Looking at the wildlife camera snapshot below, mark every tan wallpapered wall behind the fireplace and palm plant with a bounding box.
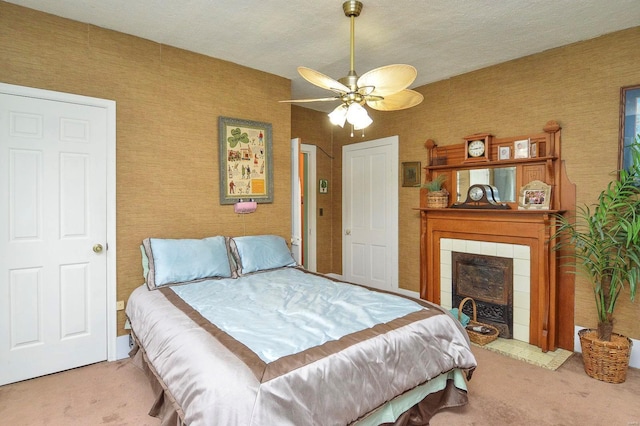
[292,27,640,338]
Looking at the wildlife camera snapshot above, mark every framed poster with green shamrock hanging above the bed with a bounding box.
[218,117,273,204]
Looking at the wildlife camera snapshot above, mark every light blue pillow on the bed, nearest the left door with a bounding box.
[142,236,234,290]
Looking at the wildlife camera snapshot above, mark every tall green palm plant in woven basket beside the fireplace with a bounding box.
[553,136,640,383]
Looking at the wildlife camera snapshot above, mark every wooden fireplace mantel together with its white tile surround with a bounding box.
[418,121,576,352]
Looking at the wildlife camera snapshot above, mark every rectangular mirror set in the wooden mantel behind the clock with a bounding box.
[456,167,516,203]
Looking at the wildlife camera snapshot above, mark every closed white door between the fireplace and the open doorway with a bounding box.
[342,136,398,291]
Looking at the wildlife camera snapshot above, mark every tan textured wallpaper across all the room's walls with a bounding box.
[0,2,640,338]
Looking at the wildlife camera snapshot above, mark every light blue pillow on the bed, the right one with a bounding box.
[231,235,296,275]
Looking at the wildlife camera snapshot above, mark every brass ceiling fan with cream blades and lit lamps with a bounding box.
[280,0,424,130]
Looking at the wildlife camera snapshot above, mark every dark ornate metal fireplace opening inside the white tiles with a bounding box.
[451,251,513,339]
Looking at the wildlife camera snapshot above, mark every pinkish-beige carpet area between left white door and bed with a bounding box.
[0,359,160,426]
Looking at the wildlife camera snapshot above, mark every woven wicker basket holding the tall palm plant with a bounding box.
[578,329,633,383]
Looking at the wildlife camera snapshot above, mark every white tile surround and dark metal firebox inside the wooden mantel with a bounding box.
[439,238,531,343]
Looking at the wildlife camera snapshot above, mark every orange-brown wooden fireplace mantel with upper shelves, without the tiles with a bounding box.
[418,122,575,352]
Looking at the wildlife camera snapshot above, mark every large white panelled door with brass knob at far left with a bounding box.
[0,88,115,385]
